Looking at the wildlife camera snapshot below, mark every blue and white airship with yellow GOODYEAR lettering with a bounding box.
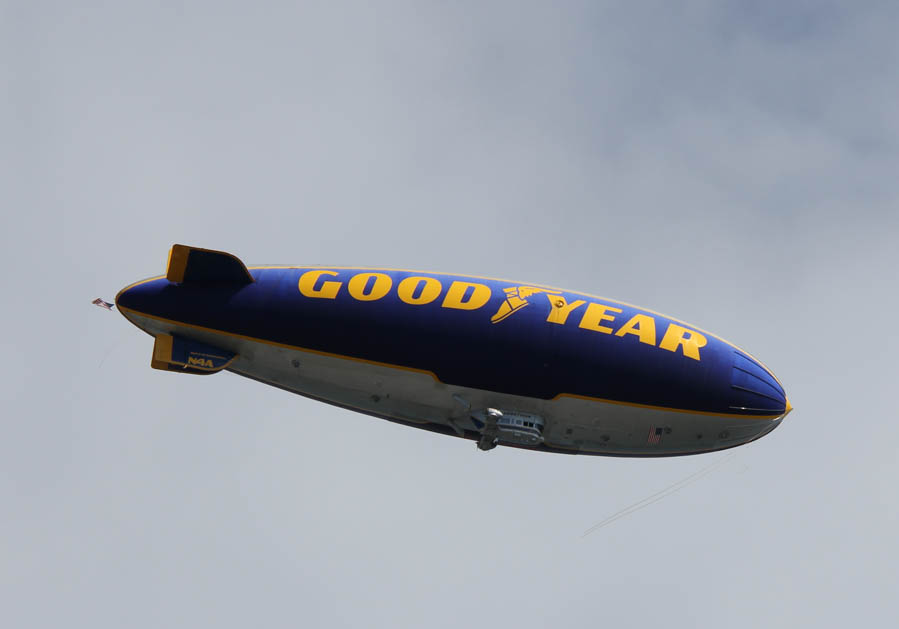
[115,244,792,457]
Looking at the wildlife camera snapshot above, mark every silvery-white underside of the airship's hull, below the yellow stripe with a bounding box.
[126,312,782,456]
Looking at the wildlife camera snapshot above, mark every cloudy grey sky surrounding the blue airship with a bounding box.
[0,1,899,628]
